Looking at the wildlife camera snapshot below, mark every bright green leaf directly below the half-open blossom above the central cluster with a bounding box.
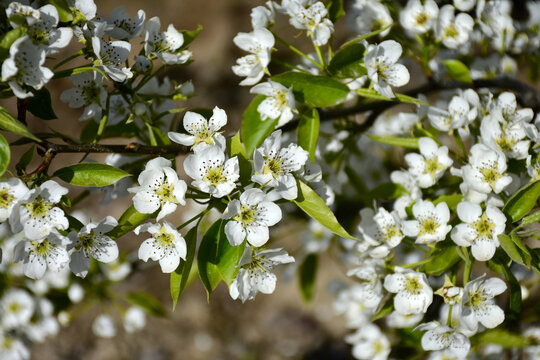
[241,95,278,158]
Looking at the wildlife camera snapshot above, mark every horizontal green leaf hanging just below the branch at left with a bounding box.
[53,163,130,187]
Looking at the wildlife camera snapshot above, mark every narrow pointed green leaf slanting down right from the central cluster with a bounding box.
[293,180,358,240]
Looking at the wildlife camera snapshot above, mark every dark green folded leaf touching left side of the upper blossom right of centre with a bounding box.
[327,44,367,78]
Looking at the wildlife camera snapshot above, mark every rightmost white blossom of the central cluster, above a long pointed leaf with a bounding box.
[251,130,309,200]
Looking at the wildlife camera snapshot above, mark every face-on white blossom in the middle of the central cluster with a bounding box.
[184,146,240,198]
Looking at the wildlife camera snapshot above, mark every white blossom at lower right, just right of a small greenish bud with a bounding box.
[461,274,506,329]
